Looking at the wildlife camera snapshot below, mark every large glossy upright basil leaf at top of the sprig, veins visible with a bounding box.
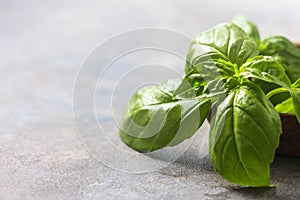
[185,23,258,73]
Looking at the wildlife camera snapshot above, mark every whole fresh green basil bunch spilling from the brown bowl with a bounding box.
[120,17,300,187]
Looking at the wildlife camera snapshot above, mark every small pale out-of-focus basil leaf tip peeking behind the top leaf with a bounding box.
[231,16,260,43]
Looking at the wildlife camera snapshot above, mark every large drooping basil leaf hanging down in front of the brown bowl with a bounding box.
[209,82,282,186]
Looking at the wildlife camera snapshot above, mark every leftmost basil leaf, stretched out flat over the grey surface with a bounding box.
[120,79,211,152]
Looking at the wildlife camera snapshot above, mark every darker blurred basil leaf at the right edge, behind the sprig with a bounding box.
[259,36,300,83]
